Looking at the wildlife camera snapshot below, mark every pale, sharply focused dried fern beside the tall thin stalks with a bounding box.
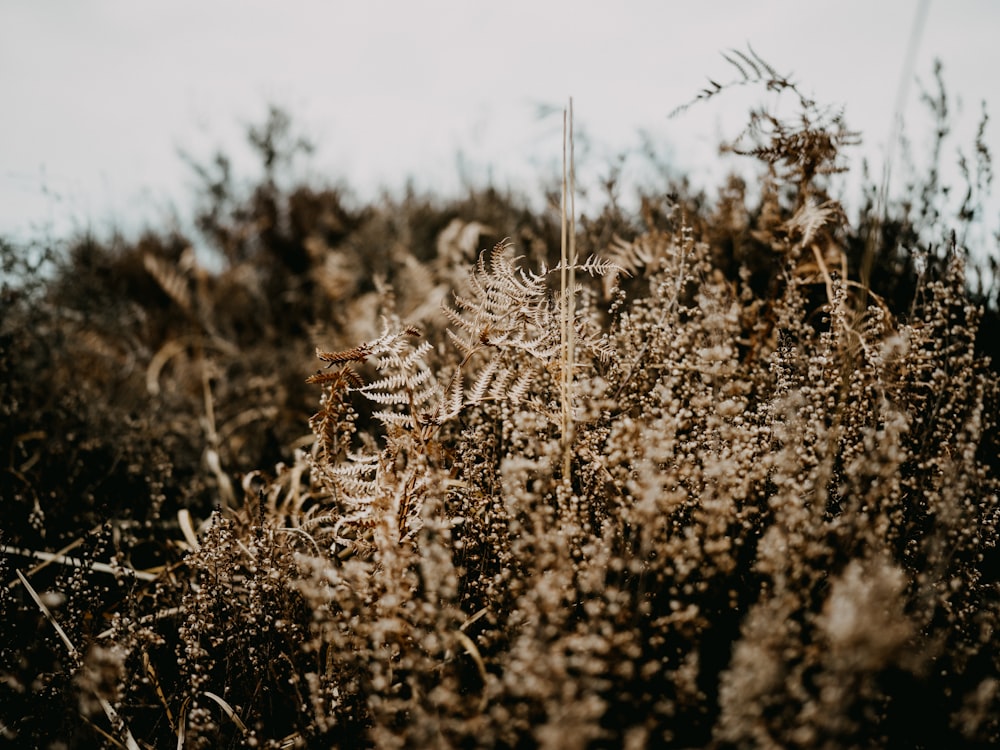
[309,241,625,539]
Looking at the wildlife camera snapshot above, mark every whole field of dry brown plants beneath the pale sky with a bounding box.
[0,53,1000,750]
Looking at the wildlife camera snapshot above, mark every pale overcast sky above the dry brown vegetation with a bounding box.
[0,0,1000,256]
